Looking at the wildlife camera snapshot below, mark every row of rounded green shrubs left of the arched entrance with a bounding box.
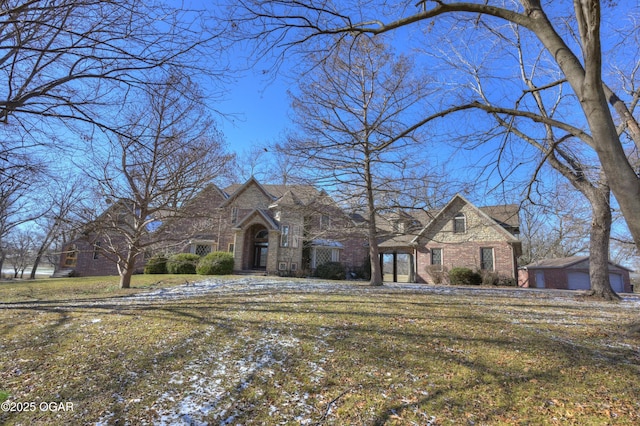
[144,251,233,275]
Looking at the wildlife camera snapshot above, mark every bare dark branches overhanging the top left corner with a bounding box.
[0,0,222,127]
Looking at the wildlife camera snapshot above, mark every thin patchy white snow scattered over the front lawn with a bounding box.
[5,277,640,425]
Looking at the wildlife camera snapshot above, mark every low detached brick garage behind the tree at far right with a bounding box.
[518,256,633,293]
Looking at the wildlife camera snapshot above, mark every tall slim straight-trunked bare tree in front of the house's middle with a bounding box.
[279,37,428,285]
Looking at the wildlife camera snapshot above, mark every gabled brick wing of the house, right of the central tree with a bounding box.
[380,194,522,284]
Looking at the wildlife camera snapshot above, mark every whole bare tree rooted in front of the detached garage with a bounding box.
[428,19,617,299]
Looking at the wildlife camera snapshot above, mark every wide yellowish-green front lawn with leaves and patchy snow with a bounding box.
[0,276,640,425]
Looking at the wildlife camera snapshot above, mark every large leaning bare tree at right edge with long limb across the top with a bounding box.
[233,0,640,253]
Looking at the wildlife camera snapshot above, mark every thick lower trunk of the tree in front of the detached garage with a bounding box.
[589,186,620,300]
